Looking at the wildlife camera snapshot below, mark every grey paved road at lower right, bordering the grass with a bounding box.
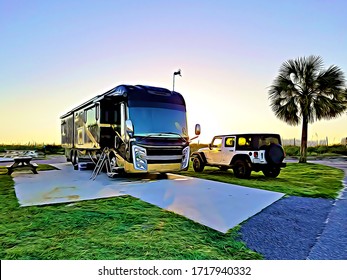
[241,160,347,260]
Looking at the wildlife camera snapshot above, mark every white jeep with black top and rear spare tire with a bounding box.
[191,133,286,178]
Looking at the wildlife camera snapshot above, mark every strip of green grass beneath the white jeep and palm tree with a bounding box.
[180,163,344,198]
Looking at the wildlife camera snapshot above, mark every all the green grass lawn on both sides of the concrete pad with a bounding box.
[0,163,343,260]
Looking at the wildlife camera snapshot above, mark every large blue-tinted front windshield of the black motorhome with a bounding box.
[129,106,188,138]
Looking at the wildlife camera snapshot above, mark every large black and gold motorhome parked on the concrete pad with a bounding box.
[60,85,200,173]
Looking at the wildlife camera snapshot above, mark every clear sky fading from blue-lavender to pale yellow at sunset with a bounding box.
[0,0,347,144]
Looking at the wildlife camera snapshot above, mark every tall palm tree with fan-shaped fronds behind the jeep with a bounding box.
[269,55,347,163]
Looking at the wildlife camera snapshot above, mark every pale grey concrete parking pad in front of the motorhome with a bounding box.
[13,163,284,233]
